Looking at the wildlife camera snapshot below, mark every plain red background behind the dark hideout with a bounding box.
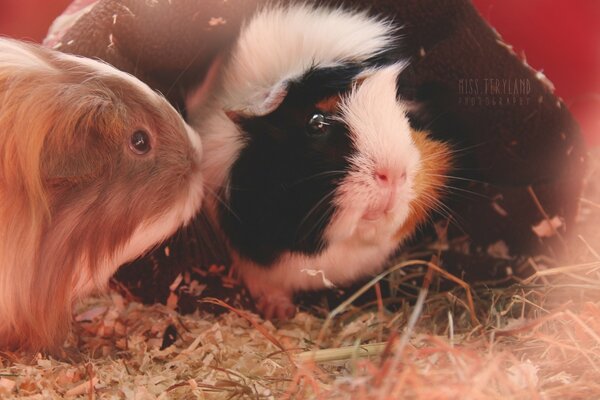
[0,0,600,145]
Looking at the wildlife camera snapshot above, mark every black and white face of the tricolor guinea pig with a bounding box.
[221,65,421,265]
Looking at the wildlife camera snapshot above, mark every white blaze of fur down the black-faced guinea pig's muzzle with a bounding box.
[325,63,420,243]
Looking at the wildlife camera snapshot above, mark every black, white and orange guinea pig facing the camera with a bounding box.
[192,5,451,318]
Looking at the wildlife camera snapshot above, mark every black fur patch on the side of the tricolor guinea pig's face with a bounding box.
[219,66,361,266]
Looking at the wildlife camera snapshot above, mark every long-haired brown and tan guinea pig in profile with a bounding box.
[0,39,203,350]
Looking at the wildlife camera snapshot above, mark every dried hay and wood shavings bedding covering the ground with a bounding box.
[0,152,600,399]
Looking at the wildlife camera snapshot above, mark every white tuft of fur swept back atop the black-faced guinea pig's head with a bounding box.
[222,4,394,115]
